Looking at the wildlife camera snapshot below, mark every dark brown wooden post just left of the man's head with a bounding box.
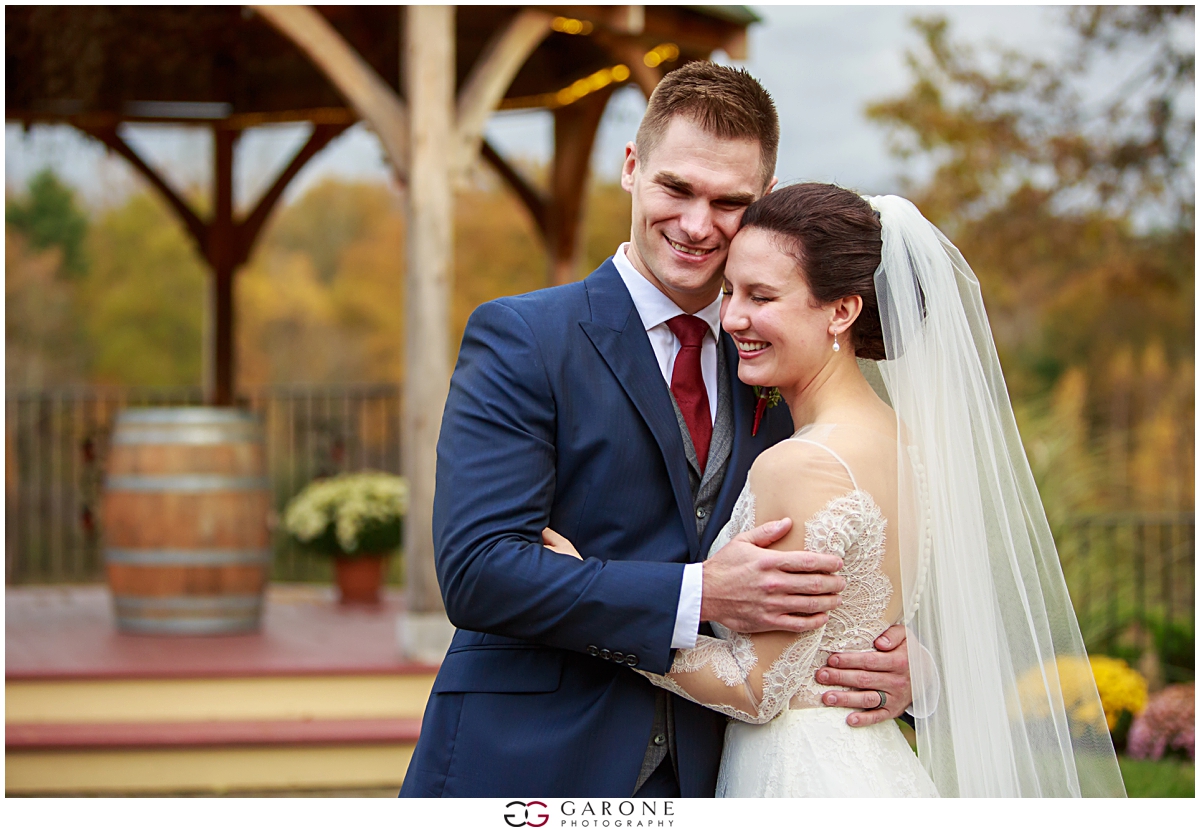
[546,86,616,284]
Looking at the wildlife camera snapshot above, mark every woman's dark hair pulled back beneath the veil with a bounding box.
[742,184,887,360]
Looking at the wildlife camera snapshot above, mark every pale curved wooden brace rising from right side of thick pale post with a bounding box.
[458,8,553,175]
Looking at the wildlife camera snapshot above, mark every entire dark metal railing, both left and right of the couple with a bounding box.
[5,385,1195,651]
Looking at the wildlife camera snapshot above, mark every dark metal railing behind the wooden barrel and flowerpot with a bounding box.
[5,384,401,584]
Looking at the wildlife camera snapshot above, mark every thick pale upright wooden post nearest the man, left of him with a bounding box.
[401,6,458,661]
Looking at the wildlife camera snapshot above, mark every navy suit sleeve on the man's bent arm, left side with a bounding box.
[433,302,684,672]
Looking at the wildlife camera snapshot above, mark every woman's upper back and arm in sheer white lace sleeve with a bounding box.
[646,422,902,723]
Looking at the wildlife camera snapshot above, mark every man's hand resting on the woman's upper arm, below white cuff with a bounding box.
[700,518,846,633]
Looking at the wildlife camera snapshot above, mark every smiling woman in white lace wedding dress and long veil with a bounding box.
[556,184,1124,797]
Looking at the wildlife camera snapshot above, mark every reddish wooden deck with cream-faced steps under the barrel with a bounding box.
[5,584,437,795]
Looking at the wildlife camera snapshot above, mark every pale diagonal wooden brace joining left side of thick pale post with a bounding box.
[251,6,410,184]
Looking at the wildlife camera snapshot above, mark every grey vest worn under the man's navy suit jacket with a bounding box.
[634,341,733,794]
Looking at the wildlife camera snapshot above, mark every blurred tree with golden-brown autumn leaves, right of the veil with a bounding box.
[868,6,1195,518]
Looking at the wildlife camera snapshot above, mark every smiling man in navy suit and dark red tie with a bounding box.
[401,62,911,798]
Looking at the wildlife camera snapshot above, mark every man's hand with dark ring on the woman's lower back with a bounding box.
[817,625,912,726]
